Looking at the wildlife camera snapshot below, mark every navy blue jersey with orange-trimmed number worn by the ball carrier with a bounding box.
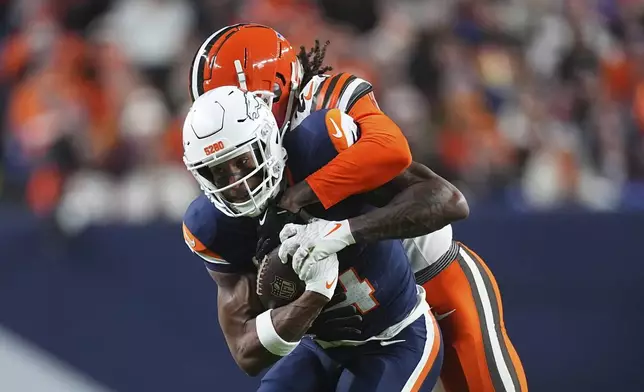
[184,109,417,339]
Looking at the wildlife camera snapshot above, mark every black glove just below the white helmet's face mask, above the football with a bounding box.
[255,200,297,260]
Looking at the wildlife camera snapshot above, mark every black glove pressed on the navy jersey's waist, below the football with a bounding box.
[307,289,362,342]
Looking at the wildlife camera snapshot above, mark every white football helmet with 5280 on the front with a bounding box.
[183,86,286,217]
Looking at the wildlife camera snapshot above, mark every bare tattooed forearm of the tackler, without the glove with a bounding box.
[349,162,469,242]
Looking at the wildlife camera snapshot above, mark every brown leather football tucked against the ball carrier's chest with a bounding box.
[257,247,306,309]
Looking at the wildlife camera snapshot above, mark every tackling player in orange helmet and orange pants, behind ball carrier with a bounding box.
[189,23,527,392]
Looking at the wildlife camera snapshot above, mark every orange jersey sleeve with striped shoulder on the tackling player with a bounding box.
[306,74,412,208]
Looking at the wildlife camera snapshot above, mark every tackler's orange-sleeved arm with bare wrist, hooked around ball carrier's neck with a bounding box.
[280,87,412,212]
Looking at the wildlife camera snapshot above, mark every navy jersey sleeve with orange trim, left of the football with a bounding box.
[182,196,252,273]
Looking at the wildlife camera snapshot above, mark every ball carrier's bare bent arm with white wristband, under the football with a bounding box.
[209,270,329,376]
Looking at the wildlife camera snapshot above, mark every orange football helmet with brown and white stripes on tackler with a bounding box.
[190,23,304,128]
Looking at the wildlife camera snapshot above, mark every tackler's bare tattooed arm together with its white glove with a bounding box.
[279,162,469,265]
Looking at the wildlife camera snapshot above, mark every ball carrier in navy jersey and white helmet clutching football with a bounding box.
[183,87,442,392]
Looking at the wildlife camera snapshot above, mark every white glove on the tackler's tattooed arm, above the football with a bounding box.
[278,219,356,274]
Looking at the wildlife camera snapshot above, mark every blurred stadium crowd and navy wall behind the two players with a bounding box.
[0,0,644,392]
